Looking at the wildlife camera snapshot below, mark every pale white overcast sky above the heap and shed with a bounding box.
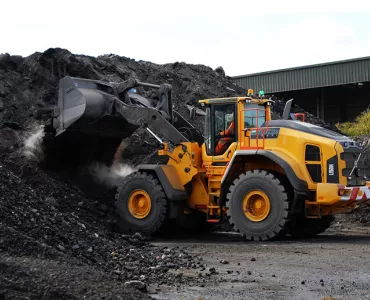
[0,0,370,76]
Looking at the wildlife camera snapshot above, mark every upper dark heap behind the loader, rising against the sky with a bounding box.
[0,49,335,162]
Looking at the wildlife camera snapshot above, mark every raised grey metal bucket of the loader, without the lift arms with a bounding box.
[53,77,142,138]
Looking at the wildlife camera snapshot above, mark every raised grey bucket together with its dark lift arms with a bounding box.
[53,76,203,145]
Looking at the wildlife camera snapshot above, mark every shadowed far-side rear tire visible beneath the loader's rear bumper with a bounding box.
[288,216,335,238]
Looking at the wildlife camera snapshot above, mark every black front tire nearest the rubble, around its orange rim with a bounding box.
[116,172,167,235]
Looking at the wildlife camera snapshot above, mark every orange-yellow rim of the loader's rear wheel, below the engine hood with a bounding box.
[243,190,270,222]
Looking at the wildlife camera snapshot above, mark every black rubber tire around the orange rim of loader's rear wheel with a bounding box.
[226,170,290,241]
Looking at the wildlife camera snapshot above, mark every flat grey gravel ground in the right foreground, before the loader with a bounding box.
[152,216,370,300]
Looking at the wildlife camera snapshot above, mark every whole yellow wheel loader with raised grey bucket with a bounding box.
[47,77,370,241]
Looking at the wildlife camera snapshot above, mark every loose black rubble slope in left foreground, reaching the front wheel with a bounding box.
[0,158,205,299]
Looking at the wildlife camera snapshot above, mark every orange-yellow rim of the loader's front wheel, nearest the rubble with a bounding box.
[128,190,152,219]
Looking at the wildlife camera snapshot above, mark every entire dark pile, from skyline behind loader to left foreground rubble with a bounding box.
[0,49,344,299]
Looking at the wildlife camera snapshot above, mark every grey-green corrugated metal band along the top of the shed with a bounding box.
[233,57,370,93]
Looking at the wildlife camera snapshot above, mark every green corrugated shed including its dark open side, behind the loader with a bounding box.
[233,56,370,122]
